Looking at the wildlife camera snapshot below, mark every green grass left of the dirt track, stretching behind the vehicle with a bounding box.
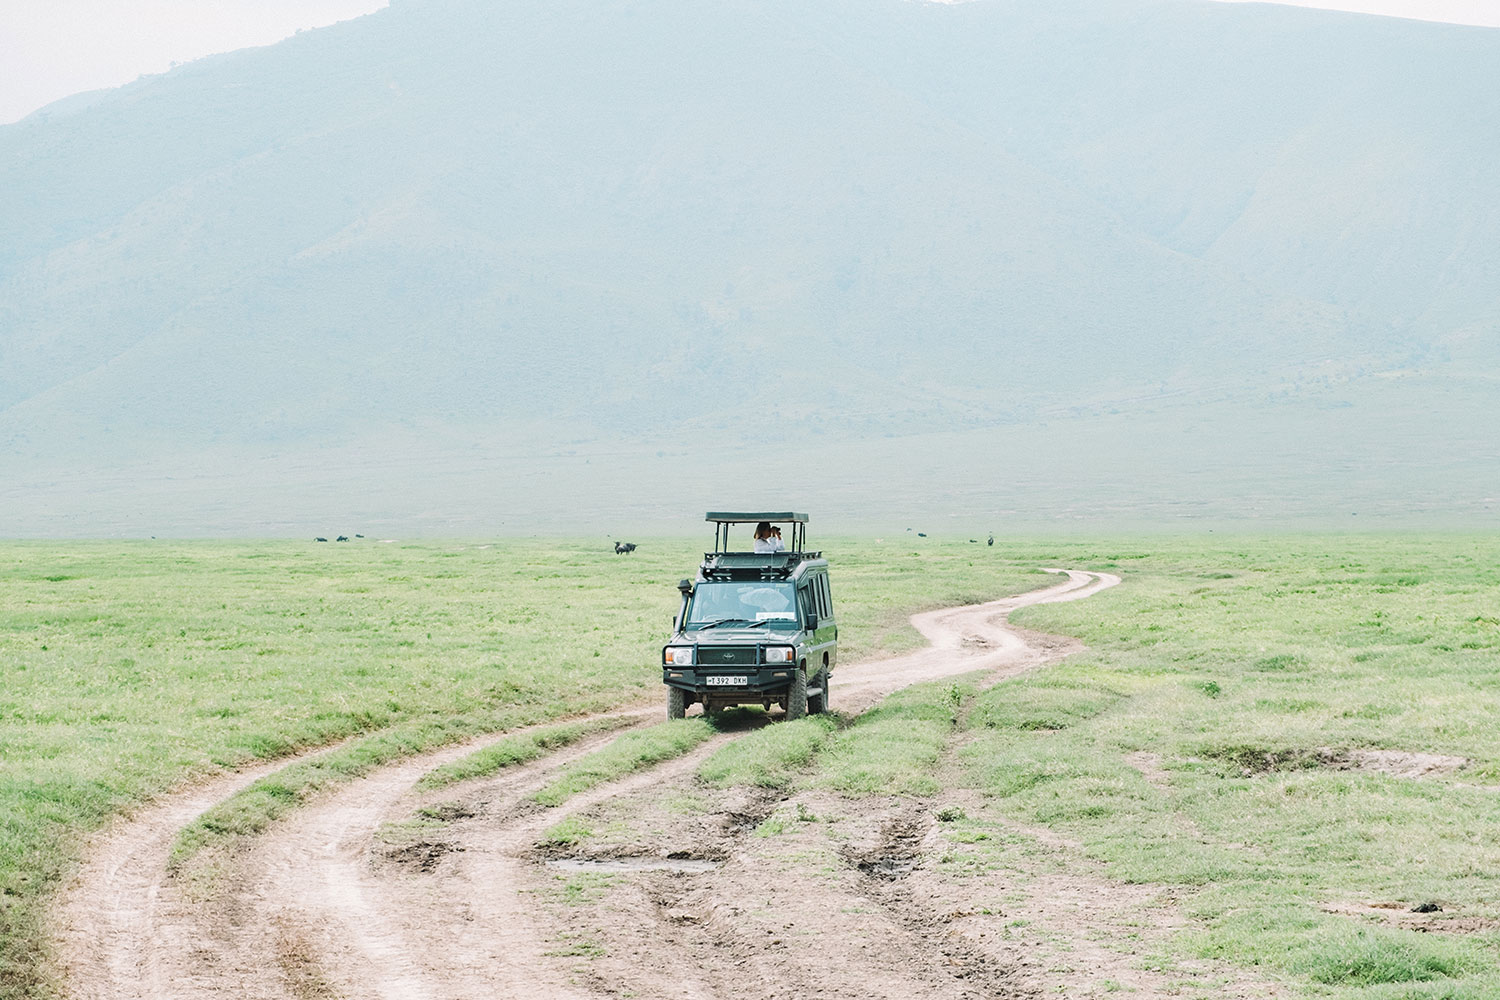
[0,540,1047,1000]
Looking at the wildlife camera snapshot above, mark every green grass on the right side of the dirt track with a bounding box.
[935,538,1500,1000]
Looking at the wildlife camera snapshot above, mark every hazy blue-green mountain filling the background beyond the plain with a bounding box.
[0,0,1500,534]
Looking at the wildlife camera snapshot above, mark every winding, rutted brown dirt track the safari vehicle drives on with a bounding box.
[56,570,1296,1000]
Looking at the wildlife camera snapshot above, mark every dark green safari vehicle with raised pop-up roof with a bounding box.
[662,511,839,718]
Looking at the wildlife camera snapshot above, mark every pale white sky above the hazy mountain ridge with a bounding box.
[0,0,1500,124]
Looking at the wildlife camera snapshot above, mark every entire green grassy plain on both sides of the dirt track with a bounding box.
[0,537,1500,1000]
